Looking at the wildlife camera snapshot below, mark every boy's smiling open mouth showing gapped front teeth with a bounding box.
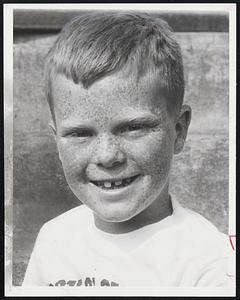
[90,175,140,190]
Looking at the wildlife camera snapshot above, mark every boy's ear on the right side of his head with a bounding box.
[174,105,192,154]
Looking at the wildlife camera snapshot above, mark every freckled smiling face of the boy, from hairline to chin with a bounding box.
[52,74,175,222]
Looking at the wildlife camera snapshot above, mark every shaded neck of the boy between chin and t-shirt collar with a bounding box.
[94,192,173,234]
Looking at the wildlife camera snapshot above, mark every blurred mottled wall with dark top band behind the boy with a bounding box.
[13,9,229,285]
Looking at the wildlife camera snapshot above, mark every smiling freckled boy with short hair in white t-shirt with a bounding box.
[23,13,230,287]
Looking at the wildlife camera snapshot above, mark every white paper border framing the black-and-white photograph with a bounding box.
[3,3,236,297]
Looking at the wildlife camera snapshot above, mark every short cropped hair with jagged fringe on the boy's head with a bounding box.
[45,12,184,121]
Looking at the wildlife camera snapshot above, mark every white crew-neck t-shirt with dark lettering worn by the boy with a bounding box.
[23,200,233,287]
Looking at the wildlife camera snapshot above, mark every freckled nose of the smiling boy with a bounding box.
[94,136,125,168]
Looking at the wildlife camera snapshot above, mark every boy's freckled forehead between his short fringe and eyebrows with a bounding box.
[52,73,169,117]
